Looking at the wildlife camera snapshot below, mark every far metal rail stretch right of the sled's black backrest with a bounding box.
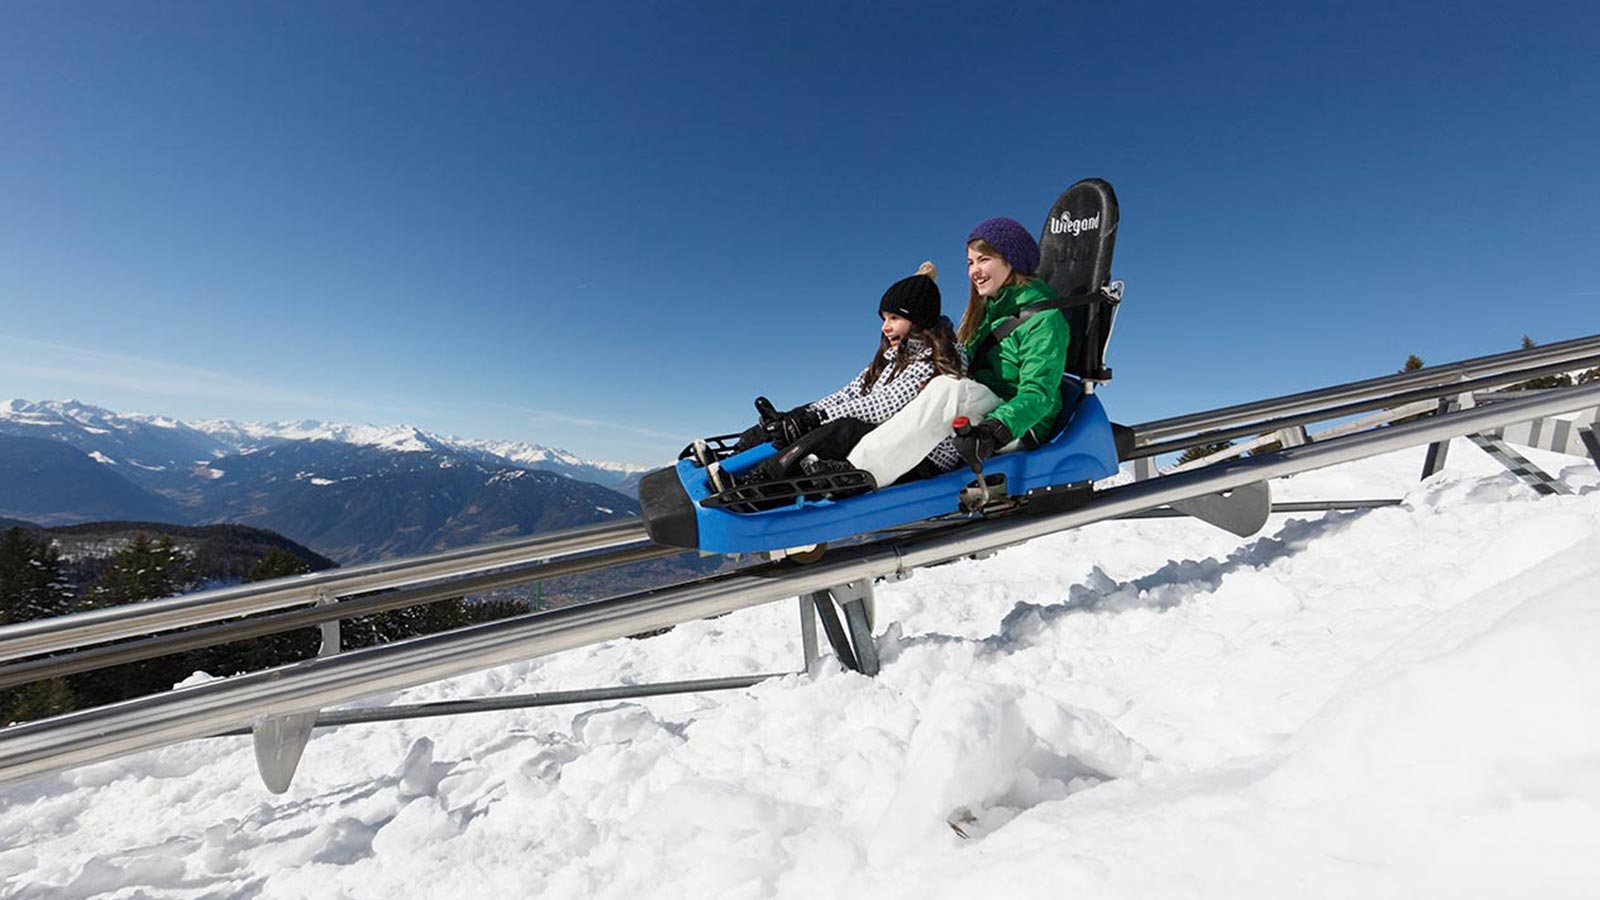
[1134,328,1600,444]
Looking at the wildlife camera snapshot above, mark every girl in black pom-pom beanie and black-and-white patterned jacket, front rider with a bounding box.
[707,263,966,490]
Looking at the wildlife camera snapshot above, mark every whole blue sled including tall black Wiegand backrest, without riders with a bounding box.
[638,178,1131,552]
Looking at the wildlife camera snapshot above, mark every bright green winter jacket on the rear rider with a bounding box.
[966,279,1072,437]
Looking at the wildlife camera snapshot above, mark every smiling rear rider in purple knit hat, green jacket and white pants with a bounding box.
[846,218,1070,485]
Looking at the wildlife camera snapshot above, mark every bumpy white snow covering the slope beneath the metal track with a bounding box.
[0,440,1600,900]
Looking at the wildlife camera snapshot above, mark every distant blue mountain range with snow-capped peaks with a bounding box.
[0,400,656,564]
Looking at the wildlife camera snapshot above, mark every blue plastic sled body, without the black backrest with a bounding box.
[638,394,1117,554]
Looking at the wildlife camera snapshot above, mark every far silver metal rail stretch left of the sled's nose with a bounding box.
[0,519,648,661]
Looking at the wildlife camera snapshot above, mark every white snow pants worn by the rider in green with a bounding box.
[846,375,1021,487]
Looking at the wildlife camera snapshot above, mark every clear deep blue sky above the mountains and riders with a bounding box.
[0,2,1600,463]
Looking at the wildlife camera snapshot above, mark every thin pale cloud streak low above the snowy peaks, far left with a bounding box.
[0,333,422,415]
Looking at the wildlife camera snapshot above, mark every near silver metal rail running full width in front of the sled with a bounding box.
[0,384,1600,781]
